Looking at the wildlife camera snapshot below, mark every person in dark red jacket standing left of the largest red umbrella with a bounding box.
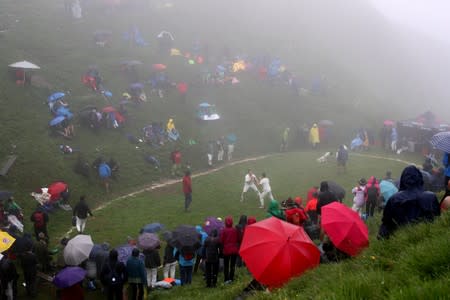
[220,216,239,284]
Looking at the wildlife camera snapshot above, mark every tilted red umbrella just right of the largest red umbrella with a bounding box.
[321,202,369,256]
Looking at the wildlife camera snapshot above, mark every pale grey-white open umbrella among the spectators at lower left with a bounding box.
[64,234,94,266]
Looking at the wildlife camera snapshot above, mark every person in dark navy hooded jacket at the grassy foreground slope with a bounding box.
[378,165,440,238]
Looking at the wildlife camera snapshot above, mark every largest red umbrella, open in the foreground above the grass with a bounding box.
[239,217,320,287]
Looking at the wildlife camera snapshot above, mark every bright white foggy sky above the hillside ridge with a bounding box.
[371,0,450,43]
